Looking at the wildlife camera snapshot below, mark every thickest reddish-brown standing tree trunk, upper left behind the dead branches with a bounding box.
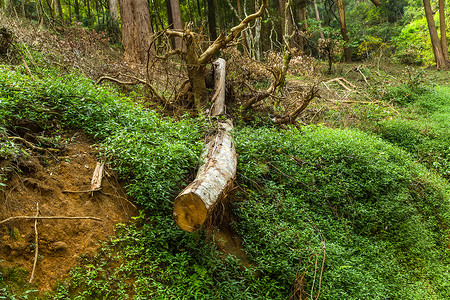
[119,0,152,63]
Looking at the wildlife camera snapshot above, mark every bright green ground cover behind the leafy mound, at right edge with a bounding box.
[374,86,450,179]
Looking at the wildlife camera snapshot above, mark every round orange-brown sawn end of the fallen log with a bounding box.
[173,193,207,232]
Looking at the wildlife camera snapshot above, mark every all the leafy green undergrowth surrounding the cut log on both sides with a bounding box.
[0,66,450,299]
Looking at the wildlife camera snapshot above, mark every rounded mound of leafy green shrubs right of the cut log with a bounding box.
[234,127,450,299]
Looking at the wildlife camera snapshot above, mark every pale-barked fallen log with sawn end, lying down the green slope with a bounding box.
[173,59,237,232]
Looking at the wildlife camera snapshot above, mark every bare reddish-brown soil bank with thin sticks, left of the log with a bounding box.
[0,136,136,292]
